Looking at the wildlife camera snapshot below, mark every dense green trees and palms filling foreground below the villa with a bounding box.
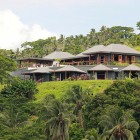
[0,79,140,140]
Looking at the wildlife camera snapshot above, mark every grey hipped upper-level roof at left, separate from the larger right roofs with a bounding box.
[43,51,74,60]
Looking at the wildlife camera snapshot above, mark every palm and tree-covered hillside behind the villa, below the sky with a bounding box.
[1,22,140,58]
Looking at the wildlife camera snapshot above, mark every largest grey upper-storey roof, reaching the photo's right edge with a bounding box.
[100,44,140,55]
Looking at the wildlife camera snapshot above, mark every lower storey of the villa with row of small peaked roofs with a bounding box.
[12,64,140,82]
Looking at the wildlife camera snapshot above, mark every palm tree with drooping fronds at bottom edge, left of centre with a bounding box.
[42,97,72,140]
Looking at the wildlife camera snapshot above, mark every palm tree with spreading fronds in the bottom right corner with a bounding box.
[99,107,139,140]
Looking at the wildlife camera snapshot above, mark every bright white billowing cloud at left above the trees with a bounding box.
[0,10,56,49]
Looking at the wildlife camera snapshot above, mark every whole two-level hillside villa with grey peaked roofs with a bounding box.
[13,44,140,81]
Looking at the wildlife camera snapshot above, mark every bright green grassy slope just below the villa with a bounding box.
[35,80,113,102]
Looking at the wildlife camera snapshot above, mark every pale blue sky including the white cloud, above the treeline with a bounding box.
[0,0,140,50]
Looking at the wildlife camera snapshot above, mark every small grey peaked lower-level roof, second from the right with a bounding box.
[89,64,112,71]
